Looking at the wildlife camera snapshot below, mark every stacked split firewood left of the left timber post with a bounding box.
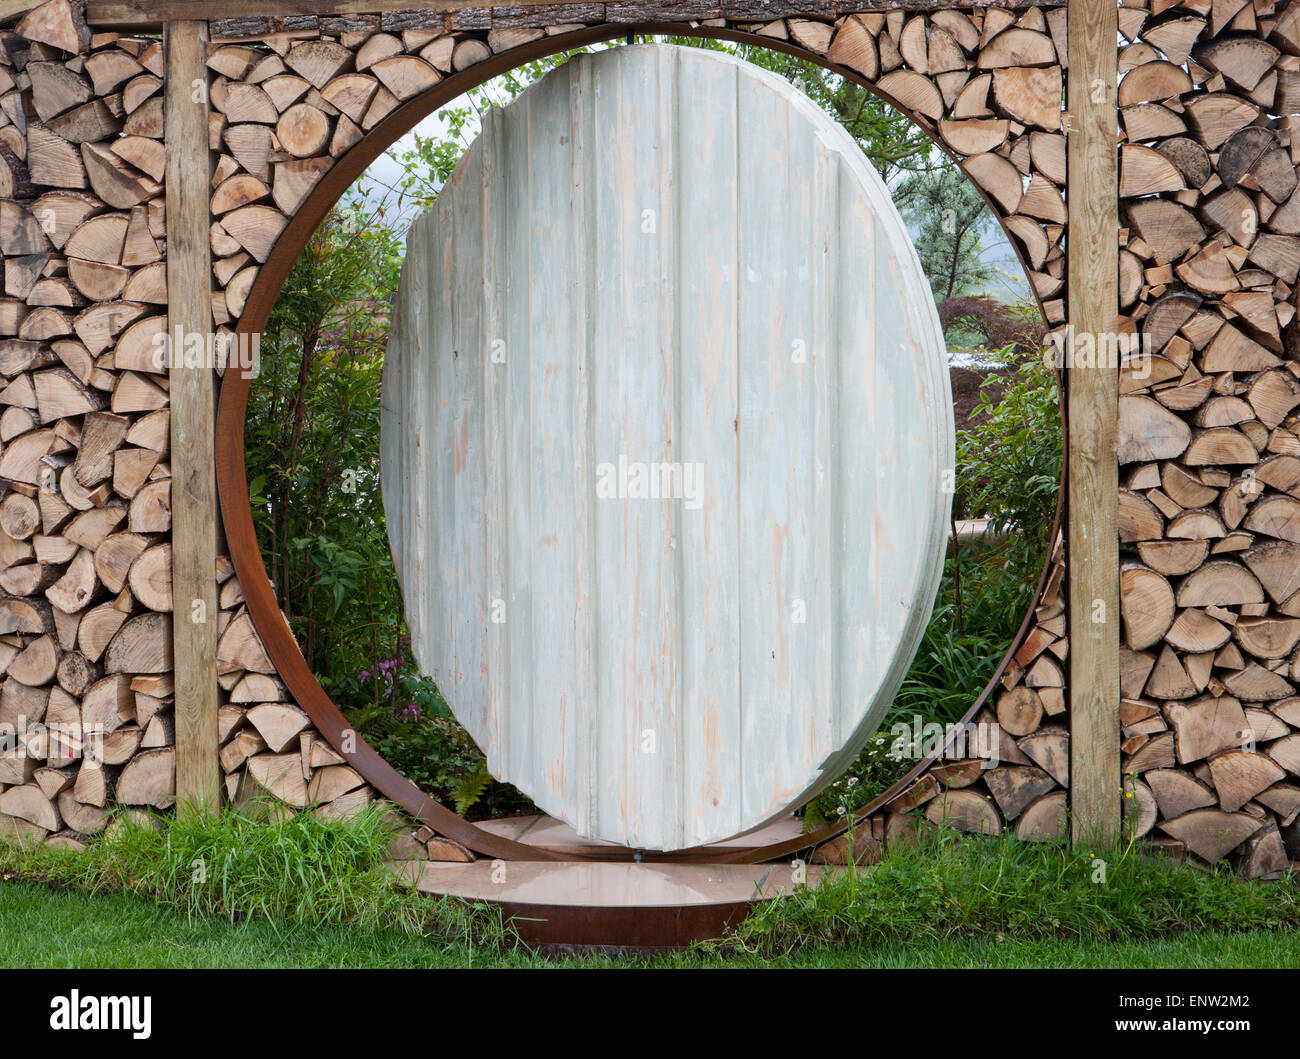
[0,3,174,847]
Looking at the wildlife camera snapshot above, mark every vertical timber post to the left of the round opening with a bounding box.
[165,21,221,812]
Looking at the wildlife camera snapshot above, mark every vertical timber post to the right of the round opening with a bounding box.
[1065,0,1121,846]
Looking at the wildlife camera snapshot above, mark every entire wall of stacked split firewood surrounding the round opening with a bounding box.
[0,0,1300,874]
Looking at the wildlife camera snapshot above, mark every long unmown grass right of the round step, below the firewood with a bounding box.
[724,828,1300,955]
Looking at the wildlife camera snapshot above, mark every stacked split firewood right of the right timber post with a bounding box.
[1118,0,1300,876]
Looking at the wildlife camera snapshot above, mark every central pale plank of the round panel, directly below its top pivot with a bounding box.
[589,45,681,848]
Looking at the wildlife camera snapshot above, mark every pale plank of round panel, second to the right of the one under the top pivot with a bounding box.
[736,70,831,819]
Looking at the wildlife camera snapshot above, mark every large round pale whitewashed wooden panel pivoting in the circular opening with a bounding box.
[382,45,953,850]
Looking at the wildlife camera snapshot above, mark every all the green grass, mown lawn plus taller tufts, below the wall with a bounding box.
[0,806,1300,968]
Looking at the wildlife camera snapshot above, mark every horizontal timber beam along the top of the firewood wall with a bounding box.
[0,0,1066,27]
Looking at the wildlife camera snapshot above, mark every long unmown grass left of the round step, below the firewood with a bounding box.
[0,802,506,943]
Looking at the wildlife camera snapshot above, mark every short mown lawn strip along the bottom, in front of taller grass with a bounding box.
[0,881,1300,968]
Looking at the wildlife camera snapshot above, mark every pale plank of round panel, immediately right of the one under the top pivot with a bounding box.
[673,53,742,845]
